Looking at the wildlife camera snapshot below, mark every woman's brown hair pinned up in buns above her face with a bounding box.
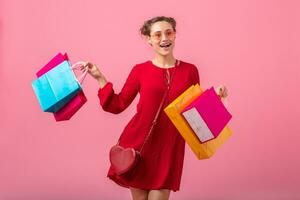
[140,16,176,36]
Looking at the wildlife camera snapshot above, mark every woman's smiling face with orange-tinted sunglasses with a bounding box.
[148,21,176,56]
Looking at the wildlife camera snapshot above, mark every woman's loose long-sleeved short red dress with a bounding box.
[98,60,199,191]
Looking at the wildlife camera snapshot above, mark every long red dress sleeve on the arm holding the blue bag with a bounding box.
[98,67,140,114]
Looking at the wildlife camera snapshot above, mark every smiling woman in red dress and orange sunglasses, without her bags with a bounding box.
[86,16,227,200]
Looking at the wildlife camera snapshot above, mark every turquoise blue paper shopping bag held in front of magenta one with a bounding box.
[32,61,82,113]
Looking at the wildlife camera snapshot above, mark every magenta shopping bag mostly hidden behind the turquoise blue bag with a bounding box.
[36,53,87,121]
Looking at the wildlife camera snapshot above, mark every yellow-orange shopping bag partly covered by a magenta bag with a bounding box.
[164,84,232,159]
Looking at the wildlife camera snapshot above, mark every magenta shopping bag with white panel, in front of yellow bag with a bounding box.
[182,87,232,143]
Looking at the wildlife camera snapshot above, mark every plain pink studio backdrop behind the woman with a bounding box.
[0,0,300,200]
